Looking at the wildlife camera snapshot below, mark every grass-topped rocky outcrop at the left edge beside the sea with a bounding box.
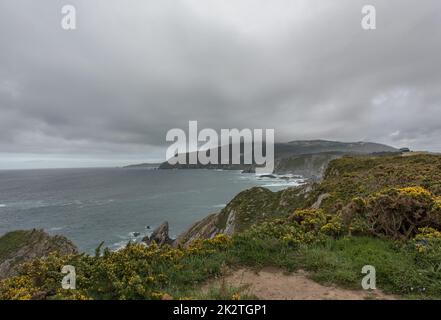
[0,229,78,279]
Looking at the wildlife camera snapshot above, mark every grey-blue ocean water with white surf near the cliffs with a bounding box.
[0,168,302,253]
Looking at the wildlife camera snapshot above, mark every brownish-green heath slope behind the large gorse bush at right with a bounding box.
[311,154,441,209]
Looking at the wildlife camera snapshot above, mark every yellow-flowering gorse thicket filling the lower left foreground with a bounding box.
[0,235,232,300]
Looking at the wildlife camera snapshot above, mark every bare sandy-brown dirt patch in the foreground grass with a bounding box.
[210,268,396,300]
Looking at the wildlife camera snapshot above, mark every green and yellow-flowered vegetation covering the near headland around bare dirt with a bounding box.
[0,155,441,299]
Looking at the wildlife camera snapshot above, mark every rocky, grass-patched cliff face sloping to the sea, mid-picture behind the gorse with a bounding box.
[174,185,311,247]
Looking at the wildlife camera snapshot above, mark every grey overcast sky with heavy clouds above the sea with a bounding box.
[0,0,441,168]
